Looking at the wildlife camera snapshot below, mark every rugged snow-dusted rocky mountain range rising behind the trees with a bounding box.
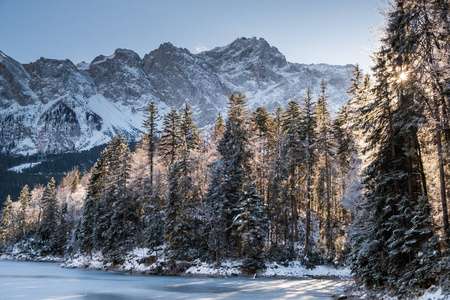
[0,38,354,154]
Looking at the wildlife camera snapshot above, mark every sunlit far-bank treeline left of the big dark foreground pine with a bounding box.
[0,82,358,272]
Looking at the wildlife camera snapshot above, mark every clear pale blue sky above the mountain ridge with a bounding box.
[0,0,384,71]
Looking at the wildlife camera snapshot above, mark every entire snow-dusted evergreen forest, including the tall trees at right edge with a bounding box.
[0,0,450,298]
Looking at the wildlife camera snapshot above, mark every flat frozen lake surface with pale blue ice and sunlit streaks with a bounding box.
[0,261,345,300]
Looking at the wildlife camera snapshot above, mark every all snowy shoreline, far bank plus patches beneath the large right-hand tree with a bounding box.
[0,249,448,300]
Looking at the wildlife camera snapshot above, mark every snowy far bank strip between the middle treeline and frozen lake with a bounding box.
[0,249,352,280]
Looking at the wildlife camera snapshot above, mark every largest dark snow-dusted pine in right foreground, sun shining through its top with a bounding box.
[352,29,439,296]
